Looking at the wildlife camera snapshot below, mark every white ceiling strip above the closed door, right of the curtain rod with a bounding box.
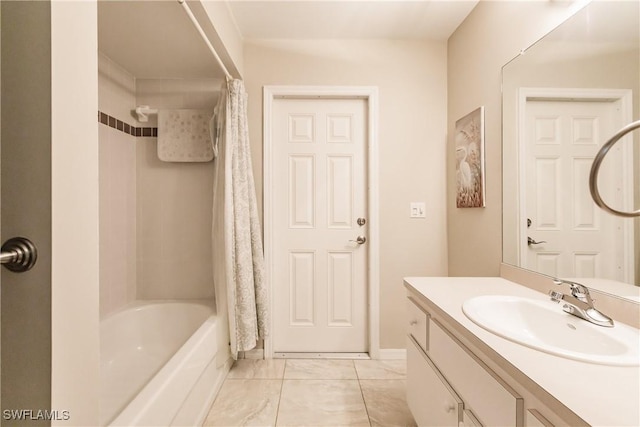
[228,0,478,40]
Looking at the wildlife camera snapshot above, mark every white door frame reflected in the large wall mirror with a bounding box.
[516,87,634,283]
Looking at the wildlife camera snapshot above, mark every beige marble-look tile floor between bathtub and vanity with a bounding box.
[204,359,415,427]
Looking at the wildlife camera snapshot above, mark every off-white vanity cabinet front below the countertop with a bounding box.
[407,298,536,427]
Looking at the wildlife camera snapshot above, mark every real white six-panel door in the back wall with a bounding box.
[271,98,368,353]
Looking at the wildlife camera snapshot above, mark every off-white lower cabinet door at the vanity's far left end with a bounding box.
[407,336,463,427]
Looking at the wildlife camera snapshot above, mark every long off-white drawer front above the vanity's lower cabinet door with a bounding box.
[428,318,524,426]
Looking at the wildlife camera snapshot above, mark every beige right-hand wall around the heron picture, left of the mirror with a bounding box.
[447,1,582,276]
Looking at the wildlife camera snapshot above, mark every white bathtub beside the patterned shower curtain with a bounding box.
[100,301,230,426]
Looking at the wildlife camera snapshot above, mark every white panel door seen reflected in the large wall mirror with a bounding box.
[522,101,631,281]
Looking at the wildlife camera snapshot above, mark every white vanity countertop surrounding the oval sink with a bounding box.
[405,277,640,426]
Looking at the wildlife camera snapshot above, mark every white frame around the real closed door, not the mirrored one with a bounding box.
[263,86,380,359]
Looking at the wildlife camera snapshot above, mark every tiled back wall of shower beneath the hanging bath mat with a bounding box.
[137,138,213,299]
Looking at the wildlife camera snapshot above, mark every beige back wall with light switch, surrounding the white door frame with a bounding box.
[244,40,447,349]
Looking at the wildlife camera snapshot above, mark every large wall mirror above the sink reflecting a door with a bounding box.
[502,1,640,301]
